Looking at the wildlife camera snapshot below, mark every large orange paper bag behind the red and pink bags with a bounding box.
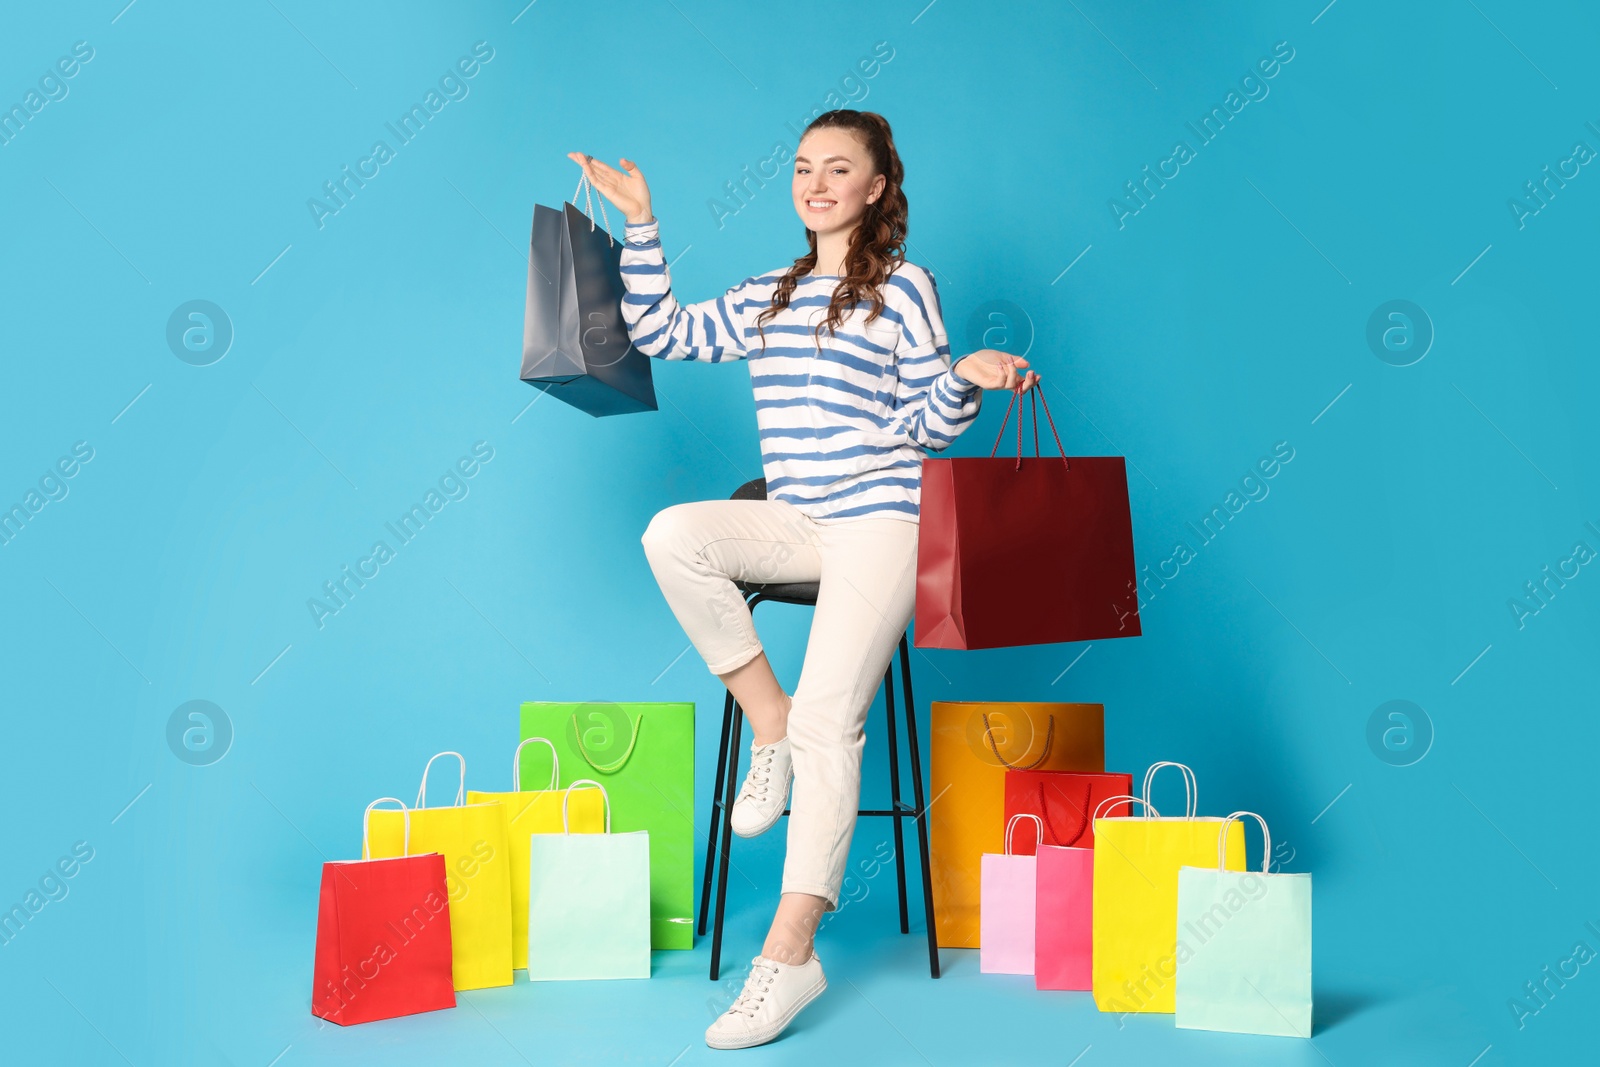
[928,701,1106,949]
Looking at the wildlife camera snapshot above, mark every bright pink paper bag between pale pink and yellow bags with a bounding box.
[1034,797,1133,989]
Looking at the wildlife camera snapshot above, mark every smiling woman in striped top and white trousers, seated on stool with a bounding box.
[570,110,1038,1048]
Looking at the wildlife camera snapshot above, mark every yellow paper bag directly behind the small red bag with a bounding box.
[370,752,512,990]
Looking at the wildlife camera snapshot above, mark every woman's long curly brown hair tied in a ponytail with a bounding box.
[755,109,907,352]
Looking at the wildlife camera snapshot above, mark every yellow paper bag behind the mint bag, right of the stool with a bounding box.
[1091,763,1245,1013]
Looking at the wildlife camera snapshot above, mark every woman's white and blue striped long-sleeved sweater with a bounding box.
[622,219,982,522]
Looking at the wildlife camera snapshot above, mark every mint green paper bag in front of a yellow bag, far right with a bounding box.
[1174,811,1310,1038]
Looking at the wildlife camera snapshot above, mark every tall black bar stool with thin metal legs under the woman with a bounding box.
[699,478,939,982]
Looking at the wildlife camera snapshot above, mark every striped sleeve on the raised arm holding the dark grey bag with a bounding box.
[622,219,750,363]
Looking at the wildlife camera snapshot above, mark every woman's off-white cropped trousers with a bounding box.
[640,501,918,910]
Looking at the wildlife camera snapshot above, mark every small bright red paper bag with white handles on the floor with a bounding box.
[310,797,456,1025]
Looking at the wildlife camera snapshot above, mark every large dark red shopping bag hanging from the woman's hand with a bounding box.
[915,387,1139,649]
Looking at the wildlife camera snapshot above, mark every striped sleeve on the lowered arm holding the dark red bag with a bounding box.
[890,270,984,451]
